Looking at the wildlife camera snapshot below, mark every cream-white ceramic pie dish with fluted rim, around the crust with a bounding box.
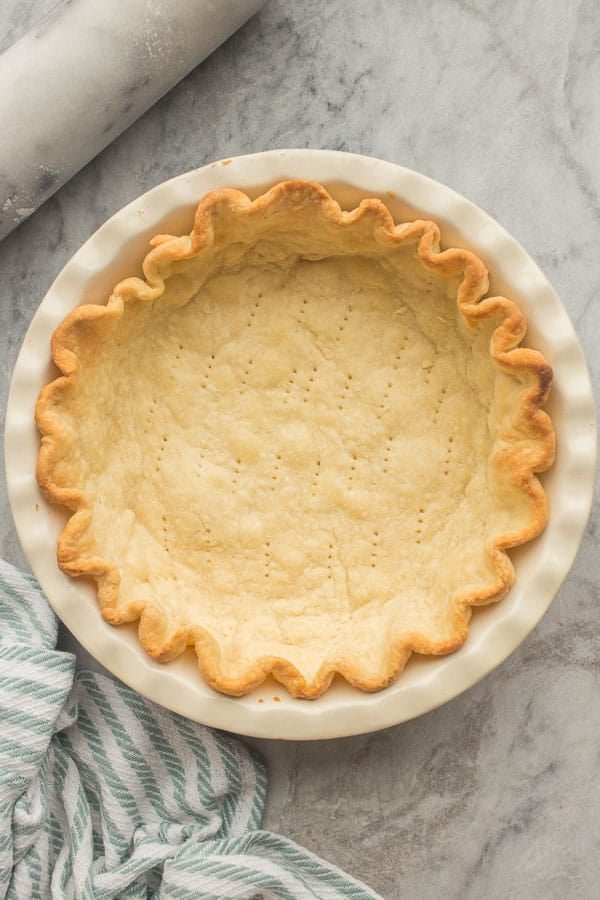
[5,150,596,739]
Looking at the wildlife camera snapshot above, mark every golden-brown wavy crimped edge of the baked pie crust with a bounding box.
[35,181,555,699]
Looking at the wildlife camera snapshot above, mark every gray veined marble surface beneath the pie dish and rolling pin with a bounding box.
[0,0,600,900]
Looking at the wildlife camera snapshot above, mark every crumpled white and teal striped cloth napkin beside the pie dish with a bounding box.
[0,562,378,900]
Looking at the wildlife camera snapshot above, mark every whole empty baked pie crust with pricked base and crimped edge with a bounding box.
[36,181,554,697]
